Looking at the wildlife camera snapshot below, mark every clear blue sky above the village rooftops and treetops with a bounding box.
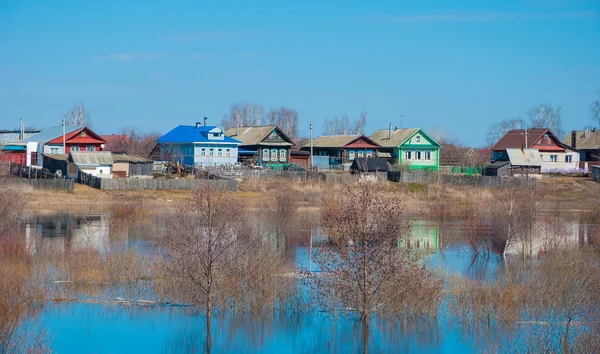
[0,0,600,145]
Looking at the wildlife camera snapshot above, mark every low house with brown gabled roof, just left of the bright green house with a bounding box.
[301,134,381,168]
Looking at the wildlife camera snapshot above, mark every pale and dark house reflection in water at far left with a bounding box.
[23,214,116,253]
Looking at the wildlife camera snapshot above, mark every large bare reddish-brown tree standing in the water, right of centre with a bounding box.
[313,183,442,352]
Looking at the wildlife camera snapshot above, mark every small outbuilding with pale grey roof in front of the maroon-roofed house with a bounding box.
[483,148,542,177]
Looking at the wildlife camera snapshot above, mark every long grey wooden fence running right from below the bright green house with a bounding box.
[388,171,537,189]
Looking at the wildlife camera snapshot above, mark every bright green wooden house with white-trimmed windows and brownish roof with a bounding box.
[370,128,441,171]
